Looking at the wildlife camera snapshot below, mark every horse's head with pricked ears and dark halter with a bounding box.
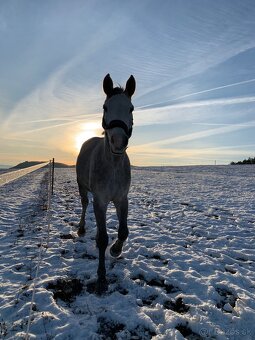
[102,74,135,155]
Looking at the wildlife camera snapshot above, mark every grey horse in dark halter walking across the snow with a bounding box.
[76,74,136,295]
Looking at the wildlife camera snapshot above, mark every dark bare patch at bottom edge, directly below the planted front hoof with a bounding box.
[97,317,125,340]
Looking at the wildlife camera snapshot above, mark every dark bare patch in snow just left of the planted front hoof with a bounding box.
[47,279,83,302]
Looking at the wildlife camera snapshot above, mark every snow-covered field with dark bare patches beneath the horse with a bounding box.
[0,165,255,340]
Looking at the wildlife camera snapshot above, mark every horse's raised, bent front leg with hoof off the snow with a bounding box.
[110,197,128,257]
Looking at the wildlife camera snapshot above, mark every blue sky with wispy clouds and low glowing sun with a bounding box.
[0,0,255,166]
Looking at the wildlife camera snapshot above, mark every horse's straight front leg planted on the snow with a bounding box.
[93,197,108,294]
